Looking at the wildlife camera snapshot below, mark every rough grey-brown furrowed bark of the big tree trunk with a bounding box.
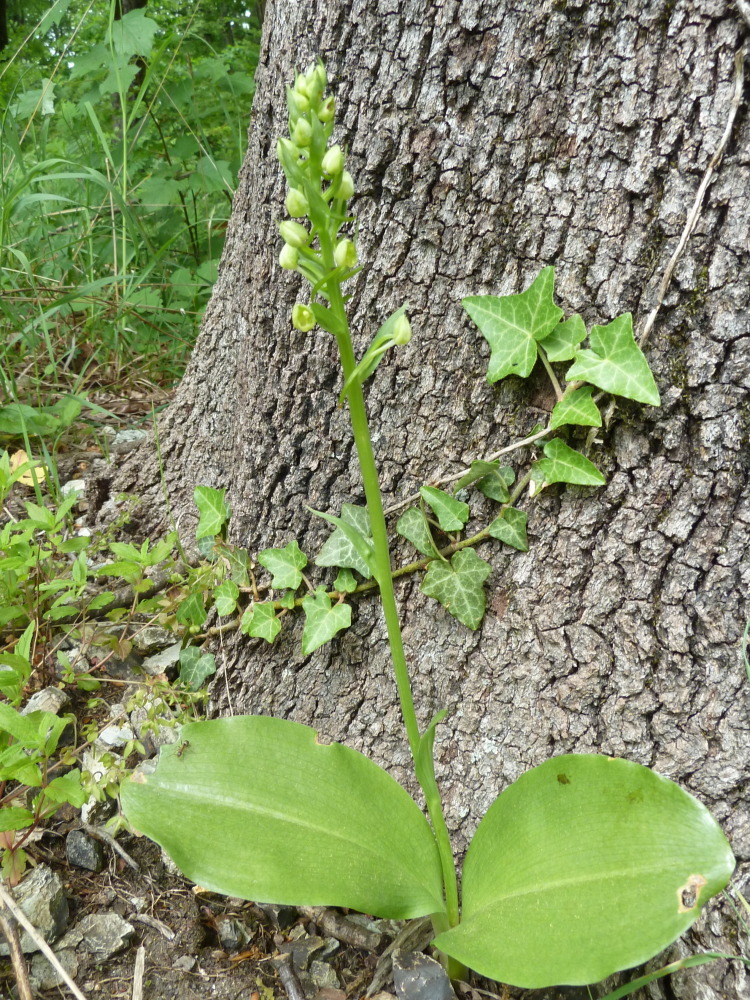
[100,0,750,1000]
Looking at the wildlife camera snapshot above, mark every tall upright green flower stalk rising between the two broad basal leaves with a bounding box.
[319,231,459,927]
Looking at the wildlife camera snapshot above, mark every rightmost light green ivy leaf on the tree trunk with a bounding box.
[566,313,661,406]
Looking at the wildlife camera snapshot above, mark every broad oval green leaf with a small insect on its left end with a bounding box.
[121,716,443,919]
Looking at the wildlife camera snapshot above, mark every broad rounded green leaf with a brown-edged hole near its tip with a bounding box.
[435,754,734,988]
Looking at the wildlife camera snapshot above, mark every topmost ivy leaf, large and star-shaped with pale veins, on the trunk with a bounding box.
[461,267,563,383]
